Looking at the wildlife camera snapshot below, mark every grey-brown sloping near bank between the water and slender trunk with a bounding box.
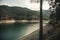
[17,24,46,40]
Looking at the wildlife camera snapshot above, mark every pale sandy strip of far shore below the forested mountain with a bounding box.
[0,20,48,24]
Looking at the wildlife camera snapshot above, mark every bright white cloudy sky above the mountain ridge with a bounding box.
[0,0,49,10]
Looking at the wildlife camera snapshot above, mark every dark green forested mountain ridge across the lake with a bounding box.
[0,5,50,20]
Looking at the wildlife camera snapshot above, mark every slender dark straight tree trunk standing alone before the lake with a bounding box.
[31,0,43,40]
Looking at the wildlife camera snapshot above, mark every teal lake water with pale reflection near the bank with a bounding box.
[0,23,39,40]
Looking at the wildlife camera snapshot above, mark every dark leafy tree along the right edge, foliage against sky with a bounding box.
[46,0,60,27]
